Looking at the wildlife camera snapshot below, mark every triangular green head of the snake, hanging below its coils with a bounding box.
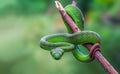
[50,48,64,60]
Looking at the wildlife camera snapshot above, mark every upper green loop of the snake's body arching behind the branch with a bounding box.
[63,5,84,33]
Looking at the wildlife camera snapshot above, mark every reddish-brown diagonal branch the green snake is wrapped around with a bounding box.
[55,1,118,74]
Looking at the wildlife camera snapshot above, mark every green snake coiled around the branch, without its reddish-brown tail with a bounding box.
[40,4,101,62]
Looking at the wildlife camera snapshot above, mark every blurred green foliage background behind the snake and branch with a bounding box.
[0,0,120,74]
